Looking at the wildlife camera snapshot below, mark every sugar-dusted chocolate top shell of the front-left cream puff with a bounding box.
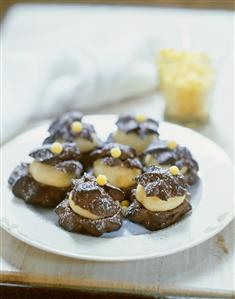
[70,174,121,218]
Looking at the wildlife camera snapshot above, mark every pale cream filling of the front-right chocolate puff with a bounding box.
[136,184,185,212]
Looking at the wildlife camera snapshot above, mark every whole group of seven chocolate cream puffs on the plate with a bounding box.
[8,111,198,237]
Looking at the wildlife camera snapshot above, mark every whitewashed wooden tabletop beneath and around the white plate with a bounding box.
[1,86,235,298]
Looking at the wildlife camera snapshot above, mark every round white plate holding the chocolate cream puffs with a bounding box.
[0,115,233,261]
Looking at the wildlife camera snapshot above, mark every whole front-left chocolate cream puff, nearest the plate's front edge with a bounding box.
[55,174,123,237]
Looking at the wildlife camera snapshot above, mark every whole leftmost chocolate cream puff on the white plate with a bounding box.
[8,143,83,208]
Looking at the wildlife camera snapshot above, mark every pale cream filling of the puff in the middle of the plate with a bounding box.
[93,160,141,188]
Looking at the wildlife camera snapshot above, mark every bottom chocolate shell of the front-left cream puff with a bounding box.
[55,199,122,237]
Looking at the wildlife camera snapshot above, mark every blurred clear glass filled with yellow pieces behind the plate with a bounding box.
[157,49,214,127]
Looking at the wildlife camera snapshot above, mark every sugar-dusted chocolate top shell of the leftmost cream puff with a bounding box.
[29,143,83,175]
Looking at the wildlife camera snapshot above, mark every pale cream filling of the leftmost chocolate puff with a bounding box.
[29,161,73,188]
